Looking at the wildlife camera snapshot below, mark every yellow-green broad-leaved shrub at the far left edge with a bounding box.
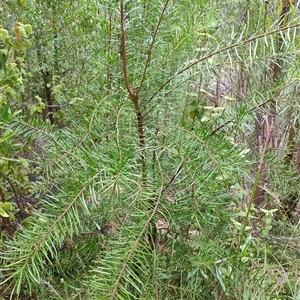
[0,22,32,234]
